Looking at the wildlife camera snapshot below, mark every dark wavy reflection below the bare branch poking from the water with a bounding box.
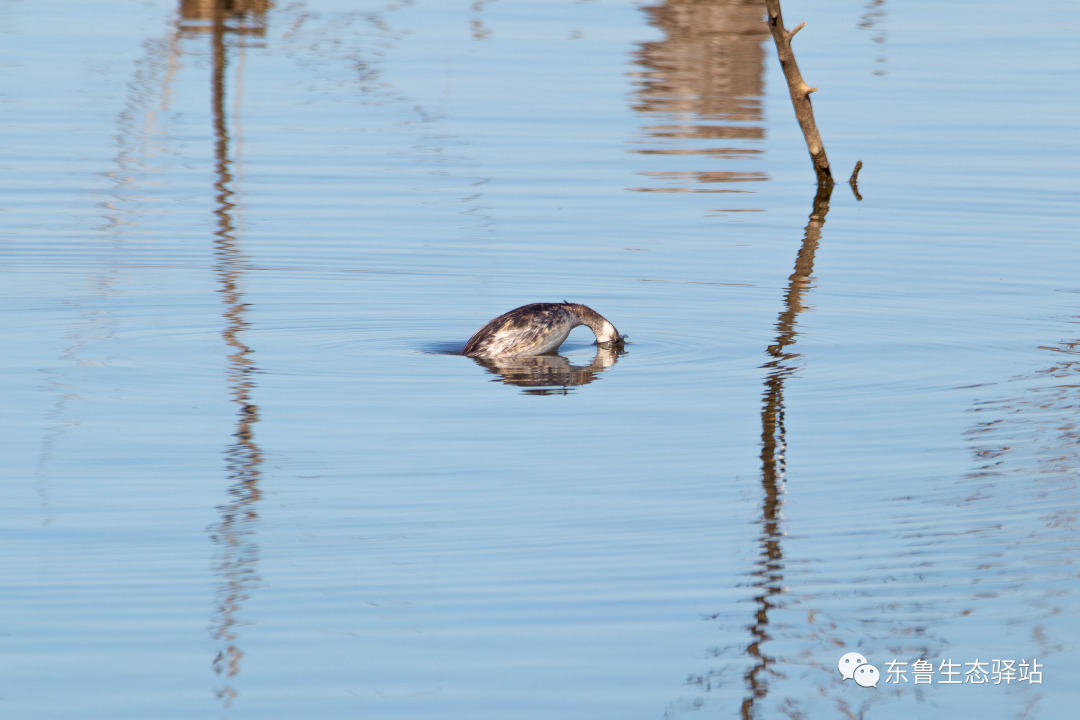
[742,182,833,720]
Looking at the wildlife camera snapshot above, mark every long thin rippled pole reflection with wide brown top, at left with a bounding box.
[180,0,269,707]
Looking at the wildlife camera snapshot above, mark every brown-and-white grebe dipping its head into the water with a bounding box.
[462,302,622,357]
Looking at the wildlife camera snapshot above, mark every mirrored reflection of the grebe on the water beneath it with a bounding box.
[472,348,626,395]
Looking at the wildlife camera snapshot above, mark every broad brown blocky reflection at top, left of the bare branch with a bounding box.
[627,0,768,192]
